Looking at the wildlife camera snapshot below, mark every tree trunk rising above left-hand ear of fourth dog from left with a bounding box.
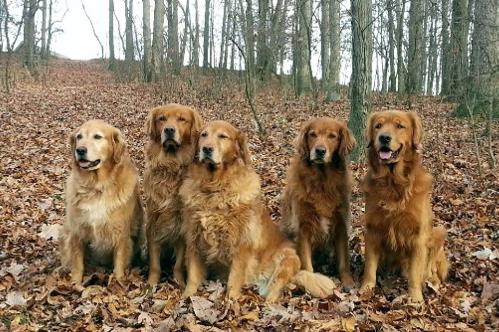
[295,0,312,96]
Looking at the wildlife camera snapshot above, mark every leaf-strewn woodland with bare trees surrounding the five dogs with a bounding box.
[0,0,499,331]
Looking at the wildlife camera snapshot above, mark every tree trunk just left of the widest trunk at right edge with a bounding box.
[448,0,468,97]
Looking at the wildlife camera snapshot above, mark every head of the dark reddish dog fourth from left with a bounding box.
[296,118,356,164]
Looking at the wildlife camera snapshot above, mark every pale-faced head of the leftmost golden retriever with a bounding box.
[70,120,125,171]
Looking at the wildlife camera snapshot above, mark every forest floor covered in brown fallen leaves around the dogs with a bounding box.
[0,61,499,331]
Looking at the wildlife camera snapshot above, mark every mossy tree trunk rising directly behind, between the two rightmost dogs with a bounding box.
[348,0,372,160]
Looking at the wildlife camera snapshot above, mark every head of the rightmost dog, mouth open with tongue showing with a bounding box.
[366,111,423,164]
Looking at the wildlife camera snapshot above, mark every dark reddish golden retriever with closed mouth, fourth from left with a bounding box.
[281,118,356,289]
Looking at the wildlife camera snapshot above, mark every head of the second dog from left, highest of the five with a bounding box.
[146,104,202,153]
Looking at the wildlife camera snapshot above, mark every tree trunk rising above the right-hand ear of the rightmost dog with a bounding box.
[406,0,424,94]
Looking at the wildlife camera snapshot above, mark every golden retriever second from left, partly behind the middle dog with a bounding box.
[144,104,202,286]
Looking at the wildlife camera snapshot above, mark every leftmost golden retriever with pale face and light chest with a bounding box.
[61,120,143,284]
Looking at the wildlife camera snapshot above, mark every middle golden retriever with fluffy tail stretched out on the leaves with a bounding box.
[180,121,335,302]
